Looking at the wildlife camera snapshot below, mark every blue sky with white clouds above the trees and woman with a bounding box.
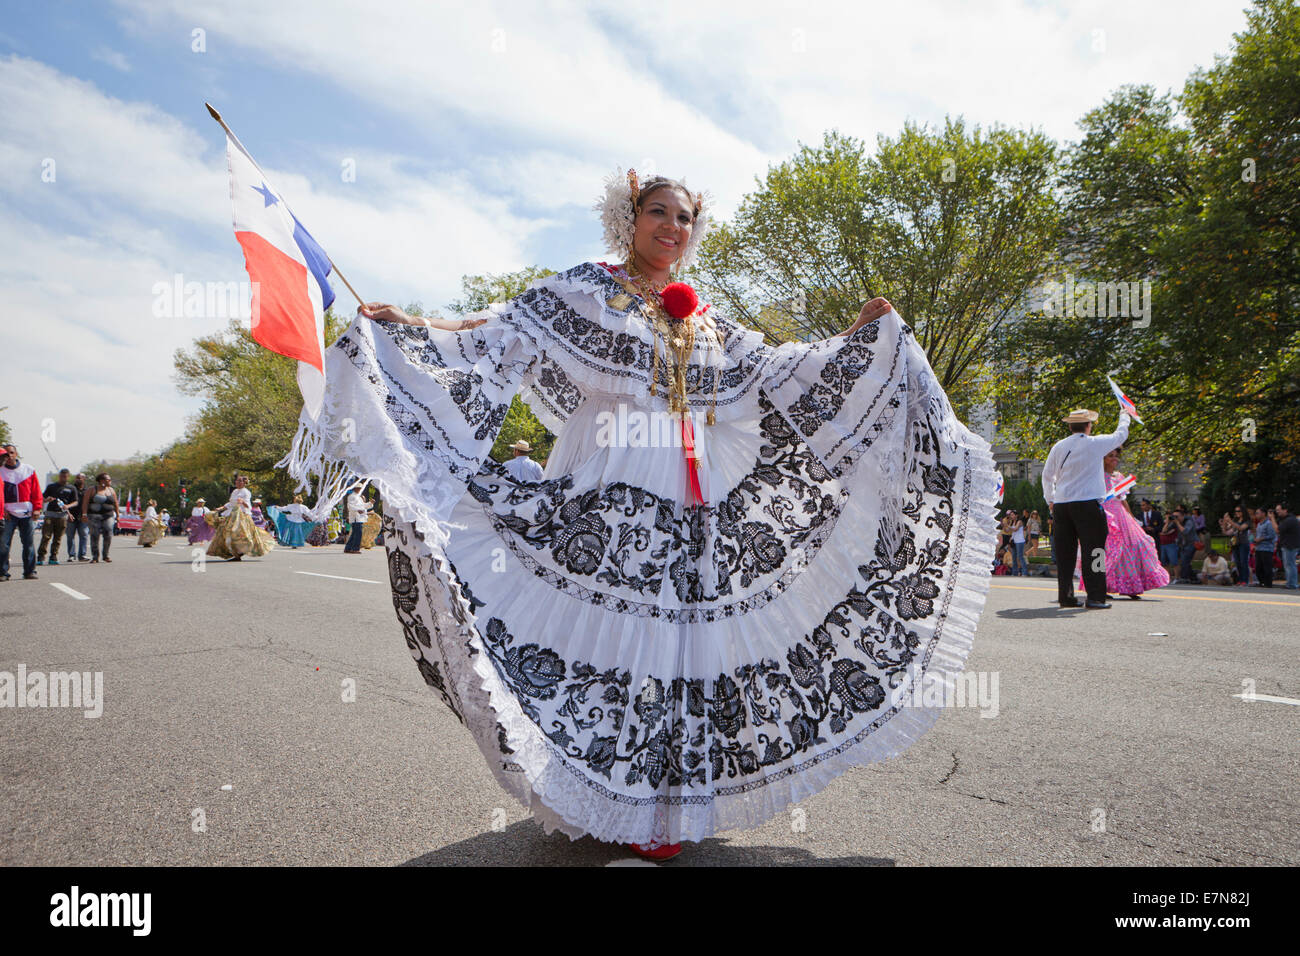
[0,0,1245,478]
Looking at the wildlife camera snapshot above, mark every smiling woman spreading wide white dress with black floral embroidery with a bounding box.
[285,176,993,858]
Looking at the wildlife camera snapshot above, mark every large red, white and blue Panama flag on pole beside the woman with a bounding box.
[226,130,334,418]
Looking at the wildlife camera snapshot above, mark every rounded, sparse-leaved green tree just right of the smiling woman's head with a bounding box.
[697,118,1060,411]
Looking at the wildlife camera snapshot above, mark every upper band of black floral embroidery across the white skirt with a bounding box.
[469,393,846,619]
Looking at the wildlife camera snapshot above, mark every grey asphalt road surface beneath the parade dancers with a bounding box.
[0,537,1300,866]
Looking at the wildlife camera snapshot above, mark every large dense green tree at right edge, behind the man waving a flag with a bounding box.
[1000,0,1300,476]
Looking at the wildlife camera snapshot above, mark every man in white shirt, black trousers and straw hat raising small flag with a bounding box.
[1043,408,1128,610]
